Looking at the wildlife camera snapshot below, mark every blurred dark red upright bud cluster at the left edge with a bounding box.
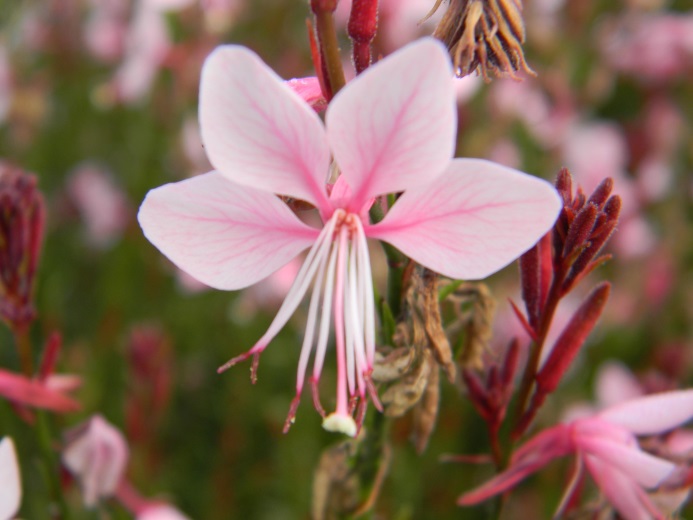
[0,163,45,329]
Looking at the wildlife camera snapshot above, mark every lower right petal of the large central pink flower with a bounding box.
[366,159,561,280]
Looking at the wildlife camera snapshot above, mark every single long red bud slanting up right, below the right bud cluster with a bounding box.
[536,282,611,394]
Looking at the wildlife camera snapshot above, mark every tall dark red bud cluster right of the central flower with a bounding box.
[513,168,621,436]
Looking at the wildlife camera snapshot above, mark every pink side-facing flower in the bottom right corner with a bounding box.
[458,390,693,520]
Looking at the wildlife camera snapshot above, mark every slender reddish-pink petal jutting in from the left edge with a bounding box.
[0,369,79,412]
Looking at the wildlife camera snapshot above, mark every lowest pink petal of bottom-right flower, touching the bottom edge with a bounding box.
[585,455,664,520]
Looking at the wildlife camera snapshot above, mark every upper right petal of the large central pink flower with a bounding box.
[326,39,457,211]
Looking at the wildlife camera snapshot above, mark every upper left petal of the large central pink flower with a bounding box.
[200,45,330,212]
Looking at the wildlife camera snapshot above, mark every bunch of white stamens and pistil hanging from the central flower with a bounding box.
[241,209,375,436]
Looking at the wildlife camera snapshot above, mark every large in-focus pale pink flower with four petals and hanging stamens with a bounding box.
[139,39,559,435]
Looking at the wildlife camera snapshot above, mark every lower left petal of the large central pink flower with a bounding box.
[138,172,319,290]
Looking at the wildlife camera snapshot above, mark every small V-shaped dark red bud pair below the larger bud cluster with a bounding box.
[462,340,520,433]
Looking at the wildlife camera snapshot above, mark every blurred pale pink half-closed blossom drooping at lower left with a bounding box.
[62,415,129,506]
